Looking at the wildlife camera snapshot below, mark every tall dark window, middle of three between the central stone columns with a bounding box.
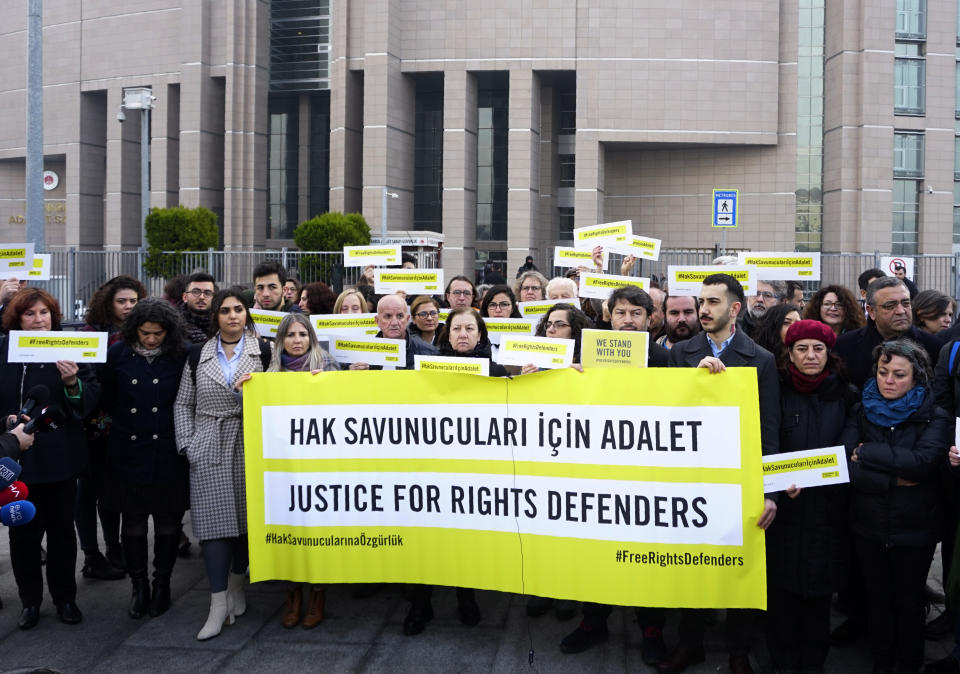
[477,72,509,241]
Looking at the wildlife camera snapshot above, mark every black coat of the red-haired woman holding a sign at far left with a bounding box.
[0,338,100,486]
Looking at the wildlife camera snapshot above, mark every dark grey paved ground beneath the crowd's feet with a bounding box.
[0,528,952,674]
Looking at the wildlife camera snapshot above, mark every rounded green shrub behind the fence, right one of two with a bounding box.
[293,211,370,284]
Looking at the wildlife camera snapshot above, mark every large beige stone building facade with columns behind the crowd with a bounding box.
[0,0,960,272]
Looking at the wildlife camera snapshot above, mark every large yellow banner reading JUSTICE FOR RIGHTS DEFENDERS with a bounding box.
[243,368,766,609]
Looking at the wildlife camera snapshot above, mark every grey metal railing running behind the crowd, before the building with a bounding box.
[31,248,960,321]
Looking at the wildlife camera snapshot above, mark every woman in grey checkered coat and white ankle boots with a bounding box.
[174,289,269,640]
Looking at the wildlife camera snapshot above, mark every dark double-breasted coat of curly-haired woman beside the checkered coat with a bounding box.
[97,342,189,486]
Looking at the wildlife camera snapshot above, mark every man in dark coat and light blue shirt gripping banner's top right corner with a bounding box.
[658,274,780,674]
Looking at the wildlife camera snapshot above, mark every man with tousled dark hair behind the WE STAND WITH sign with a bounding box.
[560,286,670,665]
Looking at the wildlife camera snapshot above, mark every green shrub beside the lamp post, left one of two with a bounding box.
[143,206,219,278]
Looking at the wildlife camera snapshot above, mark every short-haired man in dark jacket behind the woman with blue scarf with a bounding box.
[834,276,941,387]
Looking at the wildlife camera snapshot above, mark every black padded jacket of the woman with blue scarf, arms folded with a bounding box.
[843,391,953,547]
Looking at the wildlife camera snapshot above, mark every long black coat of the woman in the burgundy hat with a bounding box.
[767,375,859,597]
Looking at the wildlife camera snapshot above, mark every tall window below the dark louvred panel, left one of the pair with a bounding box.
[267,96,300,239]
